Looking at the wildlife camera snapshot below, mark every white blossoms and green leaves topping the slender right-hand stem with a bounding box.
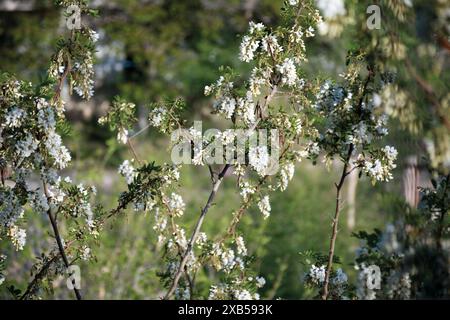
[314,77,397,183]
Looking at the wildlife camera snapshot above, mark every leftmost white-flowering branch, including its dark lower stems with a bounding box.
[0,1,101,299]
